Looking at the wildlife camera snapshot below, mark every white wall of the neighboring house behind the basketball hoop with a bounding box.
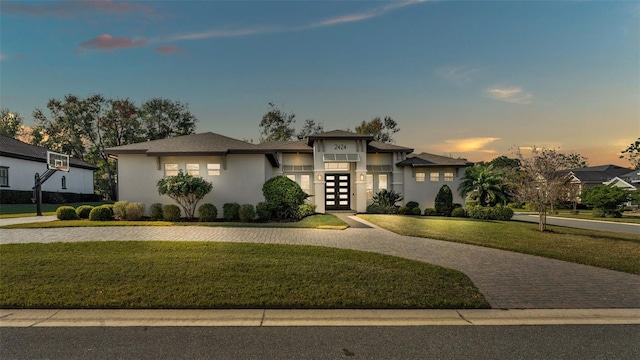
[0,156,93,194]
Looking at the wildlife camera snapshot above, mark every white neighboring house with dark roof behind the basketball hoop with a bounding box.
[0,135,97,194]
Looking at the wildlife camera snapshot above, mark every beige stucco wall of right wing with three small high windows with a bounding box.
[403,166,464,211]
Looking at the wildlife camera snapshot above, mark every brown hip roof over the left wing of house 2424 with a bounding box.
[105,132,278,166]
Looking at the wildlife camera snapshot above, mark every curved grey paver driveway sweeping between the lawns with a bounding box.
[0,218,640,309]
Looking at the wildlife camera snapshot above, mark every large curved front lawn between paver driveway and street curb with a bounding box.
[0,241,489,309]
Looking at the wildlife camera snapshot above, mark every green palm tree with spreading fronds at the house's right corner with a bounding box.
[458,164,507,206]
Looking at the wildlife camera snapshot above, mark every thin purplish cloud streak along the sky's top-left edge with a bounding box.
[2,0,155,18]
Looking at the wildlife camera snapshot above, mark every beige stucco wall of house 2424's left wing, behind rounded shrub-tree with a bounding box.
[118,154,268,217]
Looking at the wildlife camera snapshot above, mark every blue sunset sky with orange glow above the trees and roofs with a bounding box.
[0,0,640,166]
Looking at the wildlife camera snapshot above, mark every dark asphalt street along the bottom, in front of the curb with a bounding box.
[0,325,640,360]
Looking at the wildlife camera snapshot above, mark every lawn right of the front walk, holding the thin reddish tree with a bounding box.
[358,214,640,274]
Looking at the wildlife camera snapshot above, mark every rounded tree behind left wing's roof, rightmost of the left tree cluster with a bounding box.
[140,98,198,140]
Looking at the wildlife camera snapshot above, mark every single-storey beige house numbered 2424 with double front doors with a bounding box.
[106,130,472,215]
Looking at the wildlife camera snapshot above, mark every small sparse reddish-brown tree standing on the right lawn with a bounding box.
[512,147,579,231]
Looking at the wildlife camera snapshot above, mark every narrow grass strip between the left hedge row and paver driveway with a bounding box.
[0,214,347,230]
